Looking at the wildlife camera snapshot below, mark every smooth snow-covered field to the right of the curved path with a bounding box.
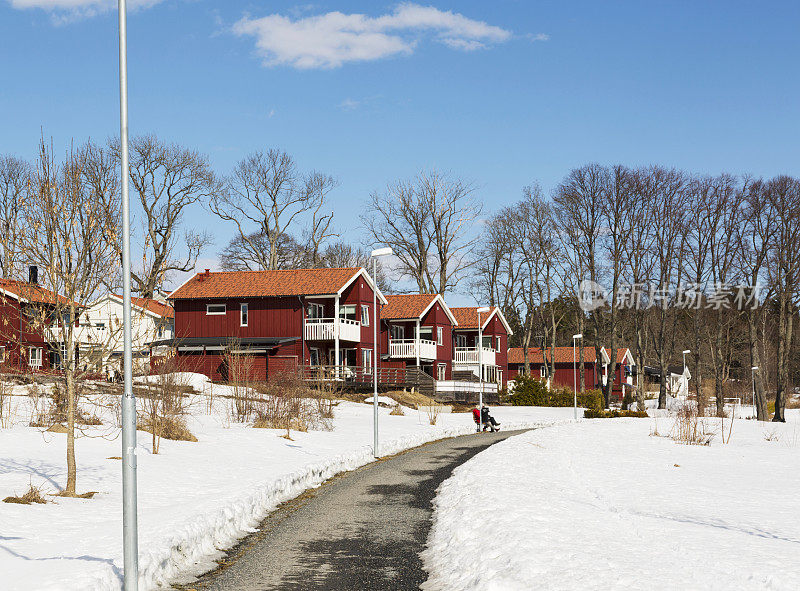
[423,411,800,591]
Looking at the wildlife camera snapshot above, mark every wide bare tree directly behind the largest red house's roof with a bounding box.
[209,150,337,270]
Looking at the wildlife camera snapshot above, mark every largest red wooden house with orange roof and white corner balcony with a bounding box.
[168,268,386,380]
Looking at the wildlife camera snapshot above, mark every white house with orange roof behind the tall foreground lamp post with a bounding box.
[77,293,175,374]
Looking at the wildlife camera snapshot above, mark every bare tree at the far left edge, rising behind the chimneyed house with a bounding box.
[0,155,30,278]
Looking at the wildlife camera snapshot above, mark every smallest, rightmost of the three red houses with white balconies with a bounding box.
[451,307,513,388]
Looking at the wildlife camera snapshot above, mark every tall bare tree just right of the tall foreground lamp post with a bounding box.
[117,135,220,297]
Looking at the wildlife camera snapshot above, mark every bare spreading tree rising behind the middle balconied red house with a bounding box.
[361,170,482,294]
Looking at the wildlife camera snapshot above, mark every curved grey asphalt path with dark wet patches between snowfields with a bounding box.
[183,431,521,591]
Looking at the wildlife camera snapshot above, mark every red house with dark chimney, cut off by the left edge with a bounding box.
[0,267,76,372]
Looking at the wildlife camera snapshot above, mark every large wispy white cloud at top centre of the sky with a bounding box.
[233,3,511,69]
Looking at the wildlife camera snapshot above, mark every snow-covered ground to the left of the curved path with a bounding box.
[0,379,572,591]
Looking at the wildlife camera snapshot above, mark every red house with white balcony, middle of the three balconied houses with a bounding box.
[381,294,456,381]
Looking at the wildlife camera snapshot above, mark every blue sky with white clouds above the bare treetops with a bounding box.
[0,0,800,296]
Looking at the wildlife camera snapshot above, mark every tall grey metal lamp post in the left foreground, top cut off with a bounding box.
[119,0,139,591]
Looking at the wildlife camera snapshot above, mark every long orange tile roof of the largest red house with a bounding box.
[169,267,361,300]
